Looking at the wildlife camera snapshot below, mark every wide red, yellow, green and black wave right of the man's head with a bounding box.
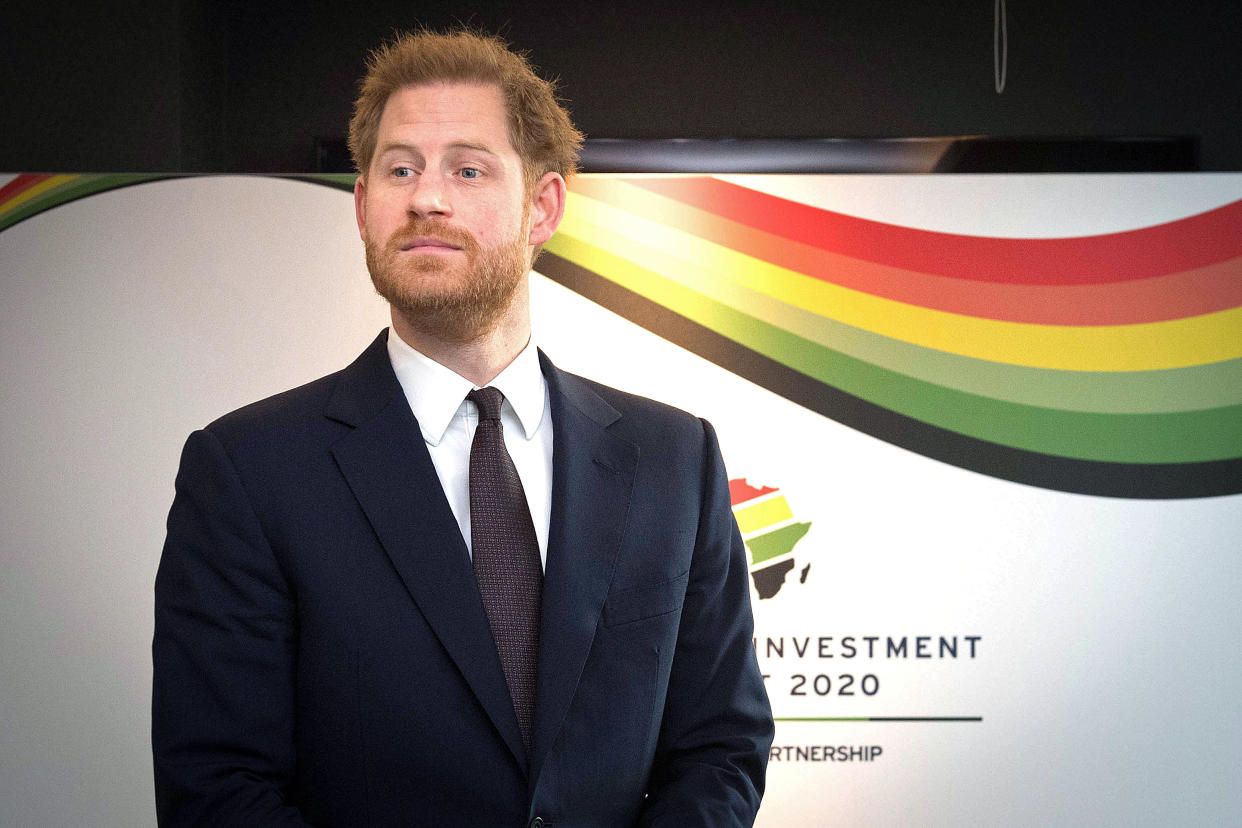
[539,175,1242,498]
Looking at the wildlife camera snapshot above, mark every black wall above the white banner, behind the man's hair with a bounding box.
[0,0,1242,173]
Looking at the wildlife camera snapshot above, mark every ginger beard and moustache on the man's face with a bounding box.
[365,213,530,344]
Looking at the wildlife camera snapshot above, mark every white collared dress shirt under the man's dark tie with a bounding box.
[388,329,551,570]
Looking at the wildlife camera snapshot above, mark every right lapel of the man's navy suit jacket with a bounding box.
[530,353,638,780]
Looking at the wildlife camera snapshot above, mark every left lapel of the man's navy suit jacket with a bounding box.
[327,334,527,768]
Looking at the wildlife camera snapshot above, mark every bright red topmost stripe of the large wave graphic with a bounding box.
[623,178,1242,284]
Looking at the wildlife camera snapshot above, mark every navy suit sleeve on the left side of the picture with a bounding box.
[152,431,306,826]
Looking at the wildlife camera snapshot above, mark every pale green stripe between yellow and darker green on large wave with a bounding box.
[545,218,1242,413]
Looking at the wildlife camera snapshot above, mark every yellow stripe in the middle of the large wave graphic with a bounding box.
[561,192,1242,371]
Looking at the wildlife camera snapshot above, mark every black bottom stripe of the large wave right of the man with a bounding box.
[535,251,1242,499]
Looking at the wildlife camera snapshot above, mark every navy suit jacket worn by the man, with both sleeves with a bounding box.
[153,334,773,828]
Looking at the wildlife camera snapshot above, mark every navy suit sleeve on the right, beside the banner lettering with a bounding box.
[638,421,774,828]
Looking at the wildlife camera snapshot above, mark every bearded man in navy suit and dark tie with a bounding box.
[153,32,773,828]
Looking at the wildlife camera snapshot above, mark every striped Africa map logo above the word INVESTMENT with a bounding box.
[729,478,811,600]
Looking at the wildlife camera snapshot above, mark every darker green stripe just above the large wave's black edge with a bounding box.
[548,235,1242,463]
